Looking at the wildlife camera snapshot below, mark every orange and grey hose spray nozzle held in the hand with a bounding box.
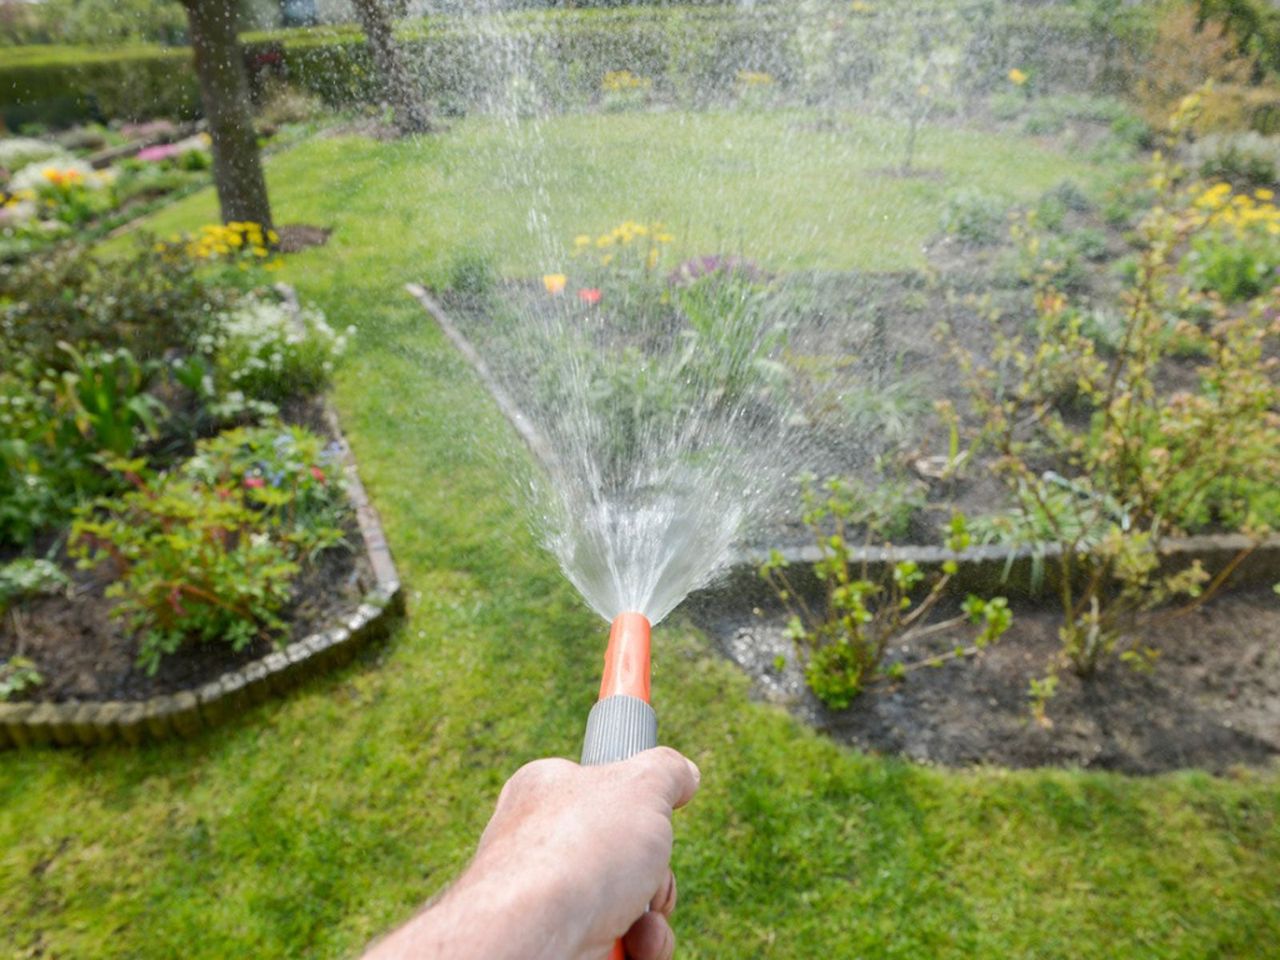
[582,613,658,960]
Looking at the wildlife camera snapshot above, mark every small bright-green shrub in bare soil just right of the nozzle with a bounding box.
[760,480,1011,709]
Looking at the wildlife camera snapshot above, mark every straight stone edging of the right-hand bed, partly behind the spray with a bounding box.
[406,283,1280,603]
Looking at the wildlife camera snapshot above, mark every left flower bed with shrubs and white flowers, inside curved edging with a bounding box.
[0,239,398,740]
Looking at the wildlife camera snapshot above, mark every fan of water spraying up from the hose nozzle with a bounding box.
[401,3,1090,622]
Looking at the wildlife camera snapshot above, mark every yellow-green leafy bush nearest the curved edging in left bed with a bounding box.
[70,428,342,673]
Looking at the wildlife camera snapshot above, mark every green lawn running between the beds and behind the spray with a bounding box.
[0,110,1280,960]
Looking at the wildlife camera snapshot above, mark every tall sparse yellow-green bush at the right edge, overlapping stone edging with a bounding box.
[960,126,1280,698]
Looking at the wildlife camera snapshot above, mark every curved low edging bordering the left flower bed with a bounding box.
[0,407,404,750]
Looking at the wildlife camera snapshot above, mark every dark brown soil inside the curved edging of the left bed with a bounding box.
[0,522,374,701]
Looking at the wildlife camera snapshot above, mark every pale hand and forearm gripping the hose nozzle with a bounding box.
[364,746,700,960]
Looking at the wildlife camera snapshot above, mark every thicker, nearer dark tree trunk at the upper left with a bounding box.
[182,0,271,228]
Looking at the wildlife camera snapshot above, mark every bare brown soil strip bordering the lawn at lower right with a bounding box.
[694,588,1280,774]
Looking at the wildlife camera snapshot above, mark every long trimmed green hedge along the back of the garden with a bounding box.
[0,0,1162,128]
